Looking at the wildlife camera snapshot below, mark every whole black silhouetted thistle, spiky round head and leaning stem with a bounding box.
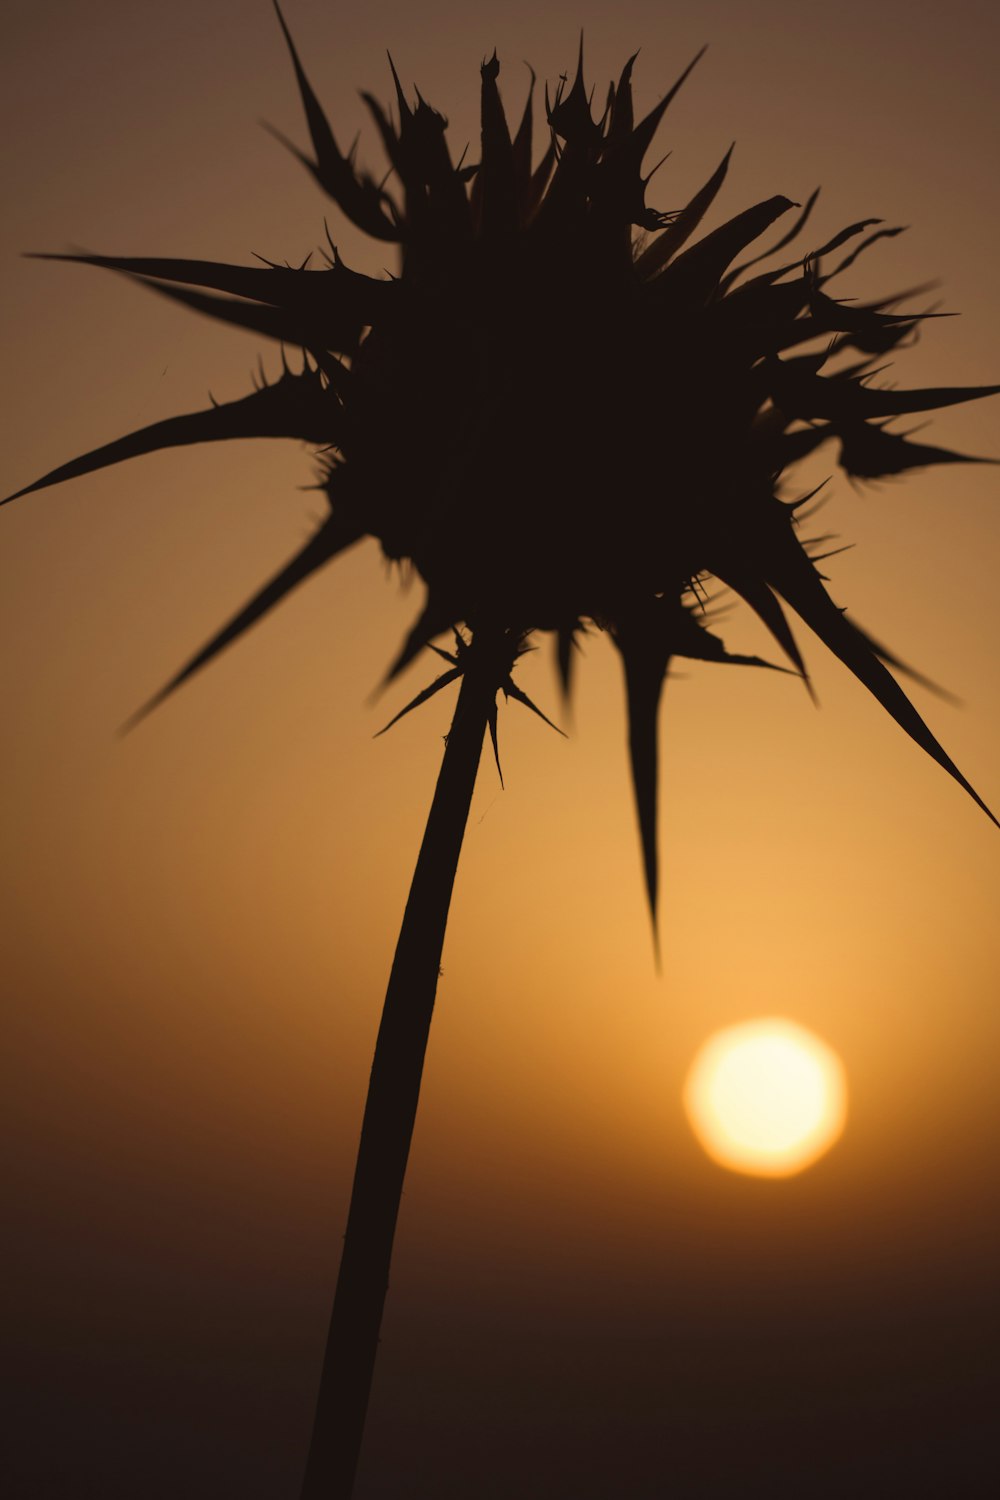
[3,6,1000,1497]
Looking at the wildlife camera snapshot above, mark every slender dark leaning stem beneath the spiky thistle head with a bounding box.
[301,639,513,1500]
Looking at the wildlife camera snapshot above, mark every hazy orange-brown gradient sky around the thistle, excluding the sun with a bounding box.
[0,0,1000,1500]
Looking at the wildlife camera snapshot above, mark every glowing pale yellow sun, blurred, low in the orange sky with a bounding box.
[684,1016,847,1178]
